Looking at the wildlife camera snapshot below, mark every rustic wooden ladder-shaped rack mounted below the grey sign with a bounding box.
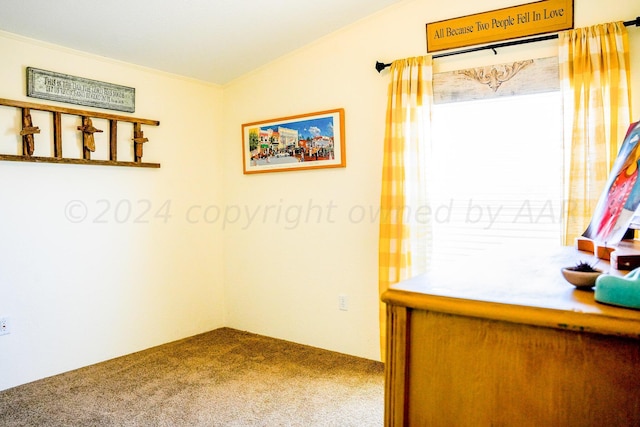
[0,98,160,168]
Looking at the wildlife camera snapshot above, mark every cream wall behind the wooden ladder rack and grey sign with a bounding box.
[0,33,224,389]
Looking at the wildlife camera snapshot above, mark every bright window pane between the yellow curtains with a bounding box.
[430,91,563,263]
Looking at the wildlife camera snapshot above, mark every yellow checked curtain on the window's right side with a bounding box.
[559,22,631,245]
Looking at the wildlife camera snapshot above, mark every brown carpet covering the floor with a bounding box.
[0,328,384,427]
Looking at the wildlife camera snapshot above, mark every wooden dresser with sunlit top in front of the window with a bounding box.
[382,248,640,427]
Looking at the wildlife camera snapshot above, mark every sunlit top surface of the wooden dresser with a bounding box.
[382,247,640,338]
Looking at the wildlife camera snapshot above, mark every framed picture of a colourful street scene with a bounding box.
[242,108,346,174]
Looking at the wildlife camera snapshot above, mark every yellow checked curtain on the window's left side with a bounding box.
[379,56,433,360]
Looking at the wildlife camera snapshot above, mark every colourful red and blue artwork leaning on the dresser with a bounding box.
[583,121,640,246]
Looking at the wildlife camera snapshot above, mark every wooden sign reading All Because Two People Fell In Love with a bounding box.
[427,0,573,52]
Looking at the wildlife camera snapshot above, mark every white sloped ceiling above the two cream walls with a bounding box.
[0,0,403,84]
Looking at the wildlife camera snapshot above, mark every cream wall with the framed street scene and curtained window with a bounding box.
[224,0,640,359]
